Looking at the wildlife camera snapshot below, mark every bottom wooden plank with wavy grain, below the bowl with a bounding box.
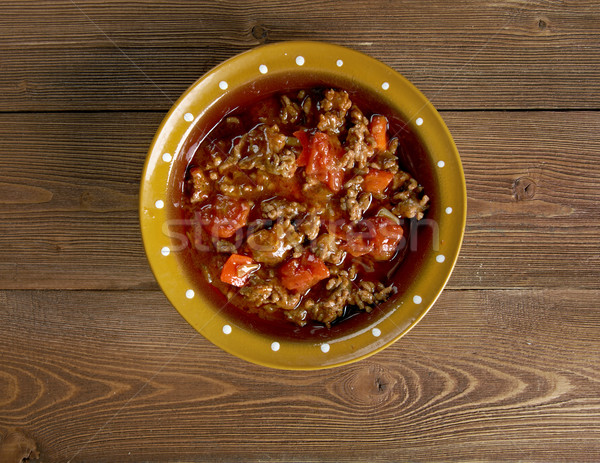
[0,289,600,462]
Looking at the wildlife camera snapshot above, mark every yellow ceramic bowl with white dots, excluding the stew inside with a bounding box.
[140,42,466,370]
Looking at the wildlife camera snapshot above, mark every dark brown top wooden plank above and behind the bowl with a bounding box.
[0,0,600,111]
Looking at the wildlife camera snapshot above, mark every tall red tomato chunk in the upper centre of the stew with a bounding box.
[306,132,344,192]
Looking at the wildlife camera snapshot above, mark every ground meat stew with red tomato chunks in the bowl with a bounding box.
[181,88,429,326]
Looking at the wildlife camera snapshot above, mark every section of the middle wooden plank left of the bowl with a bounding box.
[0,113,163,289]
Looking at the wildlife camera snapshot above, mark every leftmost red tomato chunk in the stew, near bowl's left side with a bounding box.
[200,194,250,238]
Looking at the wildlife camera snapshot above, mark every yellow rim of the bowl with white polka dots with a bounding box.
[139,41,467,370]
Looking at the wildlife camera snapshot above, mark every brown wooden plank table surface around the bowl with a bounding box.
[0,0,600,463]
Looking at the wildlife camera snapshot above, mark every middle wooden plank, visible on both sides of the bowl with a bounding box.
[0,112,600,289]
